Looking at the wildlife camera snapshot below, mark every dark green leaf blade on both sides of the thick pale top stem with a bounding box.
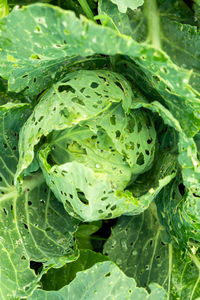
[99,0,200,91]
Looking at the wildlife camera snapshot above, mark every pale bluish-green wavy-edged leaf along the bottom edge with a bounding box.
[29,261,166,300]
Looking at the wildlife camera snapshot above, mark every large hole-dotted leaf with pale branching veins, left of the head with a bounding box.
[0,103,77,300]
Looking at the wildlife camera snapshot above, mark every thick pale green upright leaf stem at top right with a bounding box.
[144,0,161,49]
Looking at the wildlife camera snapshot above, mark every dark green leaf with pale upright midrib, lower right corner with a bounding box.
[104,204,200,300]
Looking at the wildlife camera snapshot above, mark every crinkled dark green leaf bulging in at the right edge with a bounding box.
[156,176,200,249]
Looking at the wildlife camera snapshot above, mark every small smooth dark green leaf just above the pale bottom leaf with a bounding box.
[41,250,108,291]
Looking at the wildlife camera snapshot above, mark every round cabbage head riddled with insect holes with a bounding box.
[17,70,175,221]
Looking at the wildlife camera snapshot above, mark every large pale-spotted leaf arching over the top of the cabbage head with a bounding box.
[0,2,200,136]
